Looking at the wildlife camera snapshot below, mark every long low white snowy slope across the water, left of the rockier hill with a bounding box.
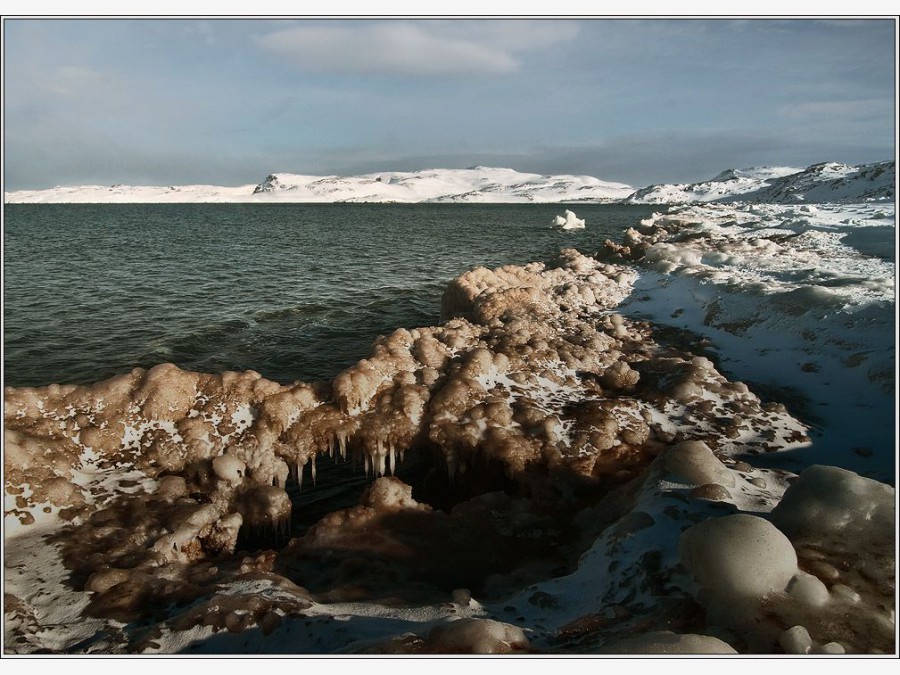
[5,167,634,203]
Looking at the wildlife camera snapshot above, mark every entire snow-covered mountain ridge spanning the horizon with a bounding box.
[4,161,896,204]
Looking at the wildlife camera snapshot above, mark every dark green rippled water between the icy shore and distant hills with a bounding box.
[4,204,659,386]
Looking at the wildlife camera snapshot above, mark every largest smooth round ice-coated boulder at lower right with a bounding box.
[679,514,798,600]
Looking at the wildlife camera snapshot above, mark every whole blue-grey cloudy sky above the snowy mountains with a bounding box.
[3,19,896,190]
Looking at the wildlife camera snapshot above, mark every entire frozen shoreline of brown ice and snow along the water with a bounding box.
[4,205,896,653]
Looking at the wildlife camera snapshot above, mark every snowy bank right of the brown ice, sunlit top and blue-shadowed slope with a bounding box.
[600,204,896,481]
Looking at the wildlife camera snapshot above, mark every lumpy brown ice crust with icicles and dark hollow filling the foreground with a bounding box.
[4,250,894,653]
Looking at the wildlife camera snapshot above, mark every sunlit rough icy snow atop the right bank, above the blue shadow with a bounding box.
[607,204,895,312]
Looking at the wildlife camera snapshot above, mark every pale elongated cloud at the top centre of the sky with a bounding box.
[259,21,577,76]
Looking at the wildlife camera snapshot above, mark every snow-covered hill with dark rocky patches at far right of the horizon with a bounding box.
[626,162,896,204]
